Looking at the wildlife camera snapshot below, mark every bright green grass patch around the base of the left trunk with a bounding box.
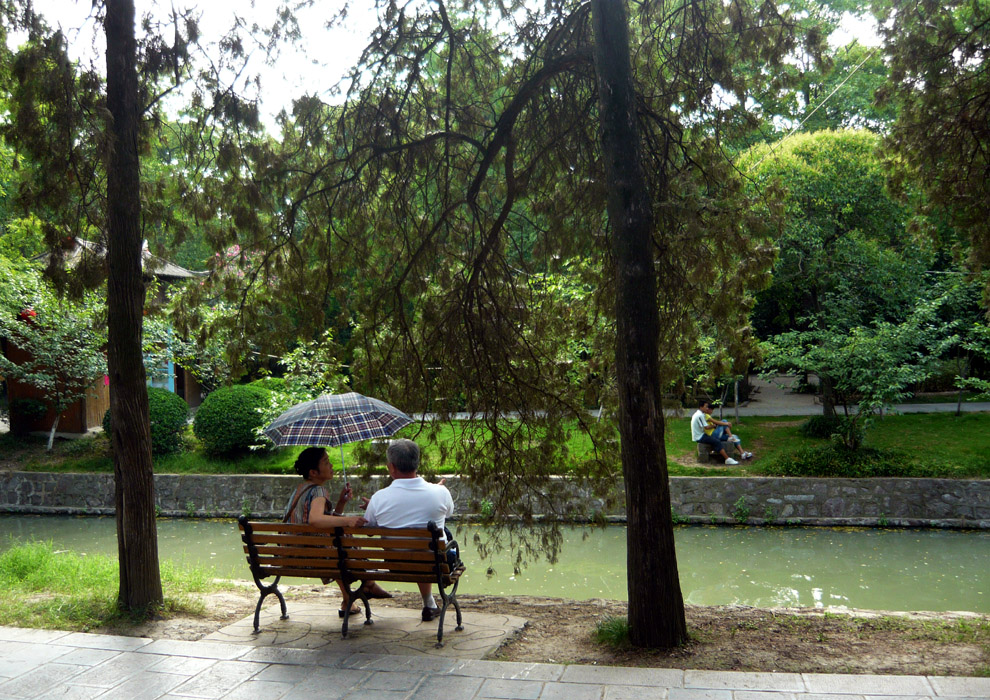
[0,542,218,631]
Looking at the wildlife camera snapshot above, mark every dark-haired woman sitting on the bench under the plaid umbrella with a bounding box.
[282,447,392,617]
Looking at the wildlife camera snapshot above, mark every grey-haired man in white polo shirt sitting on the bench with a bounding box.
[364,439,454,622]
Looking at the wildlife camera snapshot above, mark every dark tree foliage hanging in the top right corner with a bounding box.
[874,0,990,282]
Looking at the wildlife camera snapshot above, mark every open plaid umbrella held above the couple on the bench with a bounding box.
[265,391,412,481]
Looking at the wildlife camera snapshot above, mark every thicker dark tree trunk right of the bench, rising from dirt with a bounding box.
[591,0,687,647]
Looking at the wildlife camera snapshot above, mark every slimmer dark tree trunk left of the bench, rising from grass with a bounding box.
[104,0,163,611]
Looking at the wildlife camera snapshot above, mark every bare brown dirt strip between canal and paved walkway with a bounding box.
[110,586,990,676]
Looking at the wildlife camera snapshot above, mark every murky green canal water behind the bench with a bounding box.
[0,515,990,613]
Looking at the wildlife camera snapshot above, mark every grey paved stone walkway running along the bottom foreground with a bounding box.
[0,627,990,700]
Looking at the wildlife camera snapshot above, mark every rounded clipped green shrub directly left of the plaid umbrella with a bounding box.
[193,385,271,455]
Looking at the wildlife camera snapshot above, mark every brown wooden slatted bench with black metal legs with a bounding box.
[237,515,464,648]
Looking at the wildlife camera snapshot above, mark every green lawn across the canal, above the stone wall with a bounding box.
[7,411,990,478]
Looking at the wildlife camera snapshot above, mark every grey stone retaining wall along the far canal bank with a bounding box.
[0,472,990,529]
